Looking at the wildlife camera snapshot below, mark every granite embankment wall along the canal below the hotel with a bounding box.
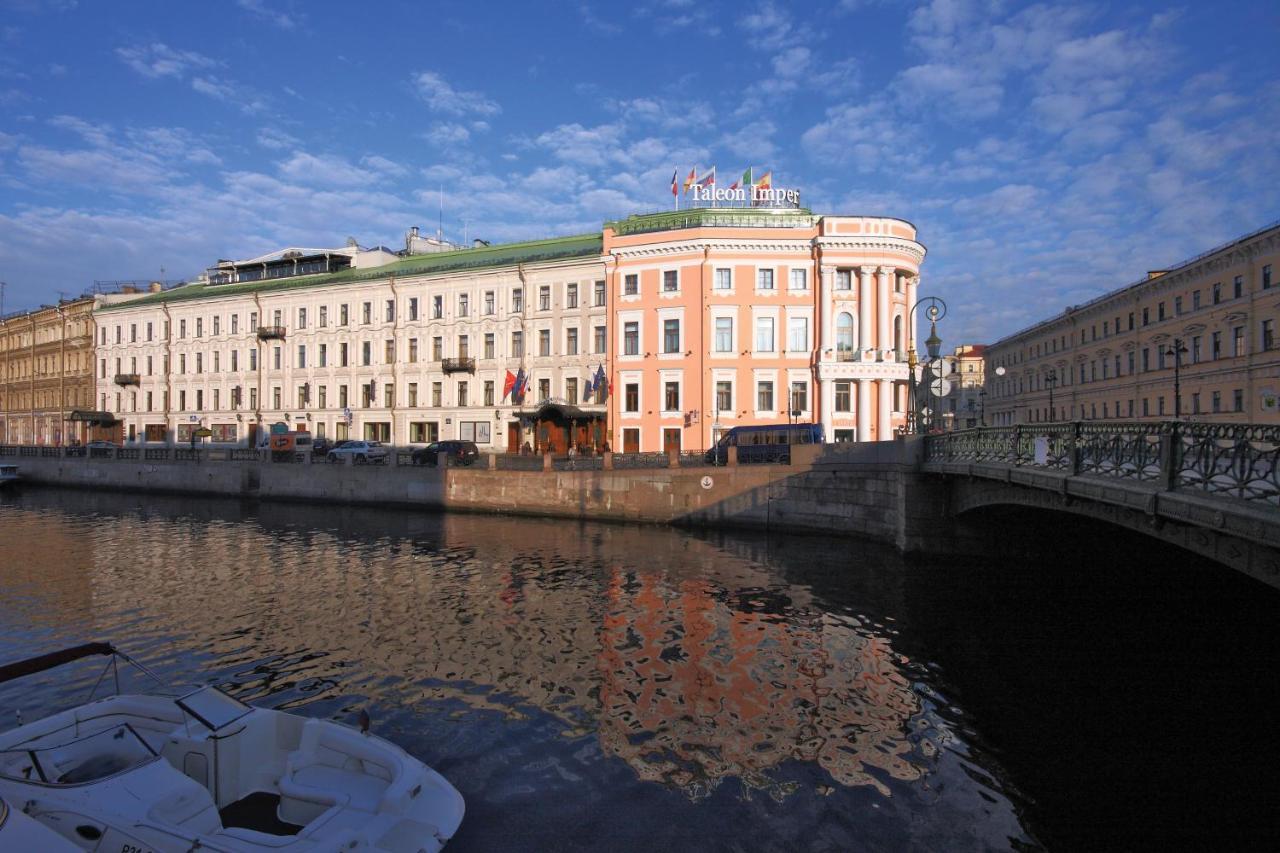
[13,439,946,551]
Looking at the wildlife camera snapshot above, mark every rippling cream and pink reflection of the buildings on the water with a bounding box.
[35,507,925,795]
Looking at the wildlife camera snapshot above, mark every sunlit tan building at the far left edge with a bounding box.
[0,297,97,444]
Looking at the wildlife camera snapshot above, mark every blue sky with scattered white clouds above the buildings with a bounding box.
[0,0,1280,346]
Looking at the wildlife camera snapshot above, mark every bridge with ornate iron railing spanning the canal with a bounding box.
[919,421,1280,588]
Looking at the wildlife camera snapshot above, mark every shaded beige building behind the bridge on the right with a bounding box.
[986,224,1280,427]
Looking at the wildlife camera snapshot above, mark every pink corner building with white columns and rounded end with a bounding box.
[603,209,924,451]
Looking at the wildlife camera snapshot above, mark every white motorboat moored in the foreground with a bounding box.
[0,643,463,853]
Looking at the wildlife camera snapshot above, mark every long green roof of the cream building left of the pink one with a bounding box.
[99,234,604,311]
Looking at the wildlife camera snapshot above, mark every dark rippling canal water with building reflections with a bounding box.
[0,488,1280,850]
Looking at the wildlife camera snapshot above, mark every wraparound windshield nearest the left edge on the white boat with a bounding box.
[0,722,156,785]
